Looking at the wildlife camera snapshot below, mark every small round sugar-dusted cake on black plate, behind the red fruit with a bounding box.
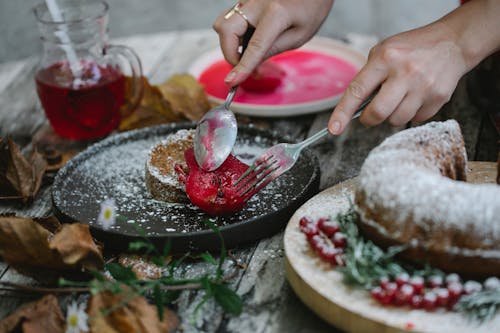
[145,129,194,202]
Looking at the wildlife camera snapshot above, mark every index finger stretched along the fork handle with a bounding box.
[328,62,387,135]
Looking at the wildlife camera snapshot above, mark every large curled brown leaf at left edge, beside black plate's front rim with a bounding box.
[0,216,104,278]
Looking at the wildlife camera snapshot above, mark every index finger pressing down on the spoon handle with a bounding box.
[224,2,287,86]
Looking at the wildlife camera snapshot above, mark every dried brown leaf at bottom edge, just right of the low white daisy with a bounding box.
[87,286,179,333]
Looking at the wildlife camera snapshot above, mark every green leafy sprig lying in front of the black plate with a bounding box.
[59,220,242,319]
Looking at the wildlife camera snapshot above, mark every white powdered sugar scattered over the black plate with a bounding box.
[53,125,318,237]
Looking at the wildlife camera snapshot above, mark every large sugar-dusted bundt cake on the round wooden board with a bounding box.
[355,120,500,277]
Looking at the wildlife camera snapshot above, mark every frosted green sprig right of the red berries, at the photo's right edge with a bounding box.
[454,289,500,322]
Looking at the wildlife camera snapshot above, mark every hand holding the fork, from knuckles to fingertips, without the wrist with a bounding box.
[328,23,467,135]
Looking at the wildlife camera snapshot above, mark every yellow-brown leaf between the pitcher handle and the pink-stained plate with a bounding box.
[158,74,210,121]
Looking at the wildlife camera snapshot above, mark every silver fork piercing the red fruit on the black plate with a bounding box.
[234,91,377,201]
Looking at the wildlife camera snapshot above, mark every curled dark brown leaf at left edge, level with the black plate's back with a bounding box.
[0,138,47,203]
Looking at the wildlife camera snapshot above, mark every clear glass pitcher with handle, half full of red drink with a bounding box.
[34,0,143,139]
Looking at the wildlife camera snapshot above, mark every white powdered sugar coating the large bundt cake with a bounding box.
[357,120,500,257]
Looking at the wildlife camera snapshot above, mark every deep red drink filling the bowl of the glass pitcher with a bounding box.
[35,60,125,139]
